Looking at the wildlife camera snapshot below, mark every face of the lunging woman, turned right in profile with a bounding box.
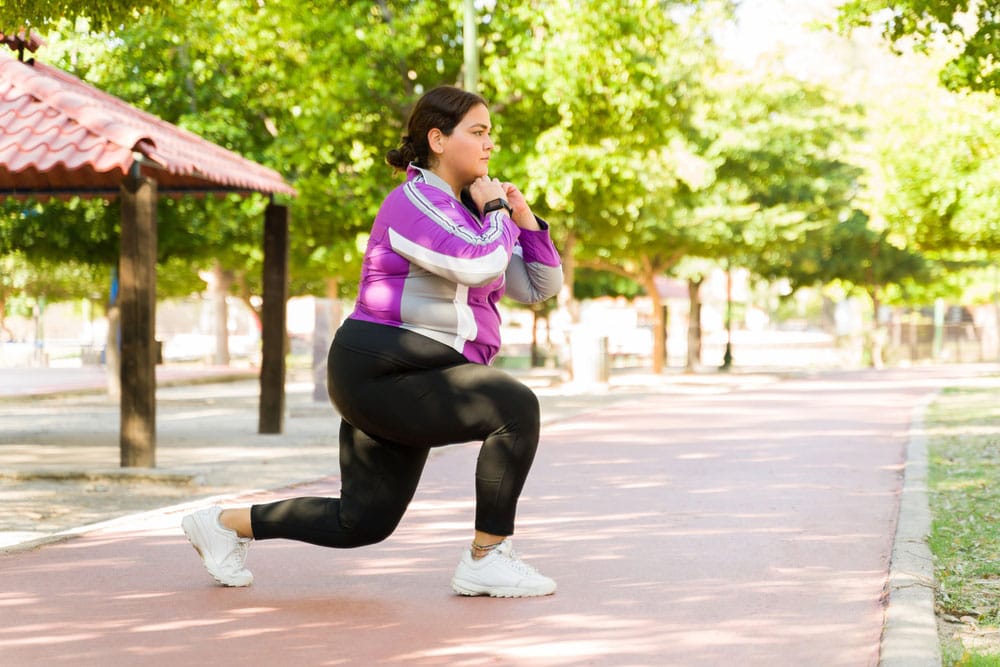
[430,104,494,191]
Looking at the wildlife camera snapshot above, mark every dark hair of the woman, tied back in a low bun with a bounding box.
[385,86,487,170]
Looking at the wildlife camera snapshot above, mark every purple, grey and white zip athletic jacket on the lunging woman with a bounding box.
[350,165,562,364]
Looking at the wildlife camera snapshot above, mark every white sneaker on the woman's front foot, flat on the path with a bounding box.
[451,538,556,598]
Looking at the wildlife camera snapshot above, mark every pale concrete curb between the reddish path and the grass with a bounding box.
[879,393,941,667]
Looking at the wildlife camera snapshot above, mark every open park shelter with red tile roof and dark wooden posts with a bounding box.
[0,44,295,467]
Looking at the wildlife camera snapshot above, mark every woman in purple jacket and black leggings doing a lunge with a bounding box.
[182,86,562,597]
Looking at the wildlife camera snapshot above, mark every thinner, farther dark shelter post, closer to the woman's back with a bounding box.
[257,201,288,433]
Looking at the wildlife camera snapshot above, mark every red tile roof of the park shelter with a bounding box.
[0,53,295,197]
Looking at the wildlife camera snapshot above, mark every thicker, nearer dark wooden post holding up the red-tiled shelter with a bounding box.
[118,171,156,468]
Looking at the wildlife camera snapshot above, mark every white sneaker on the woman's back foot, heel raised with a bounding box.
[181,507,253,586]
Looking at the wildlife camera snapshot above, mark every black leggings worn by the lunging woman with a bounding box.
[251,320,539,548]
